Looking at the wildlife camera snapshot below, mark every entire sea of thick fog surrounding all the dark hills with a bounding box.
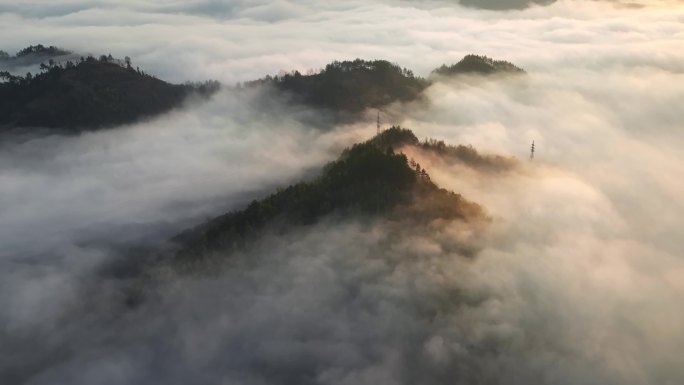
[0,1,684,385]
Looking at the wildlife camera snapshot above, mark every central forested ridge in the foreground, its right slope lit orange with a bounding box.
[173,128,485,267]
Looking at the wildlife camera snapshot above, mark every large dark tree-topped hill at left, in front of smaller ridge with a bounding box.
[0,56,218,132]
